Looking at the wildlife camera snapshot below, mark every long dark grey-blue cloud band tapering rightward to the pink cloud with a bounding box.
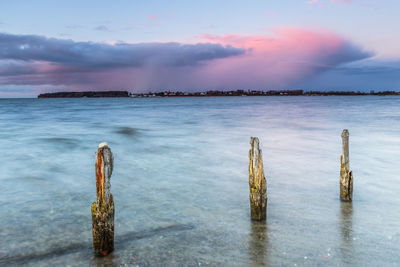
[0,33,245,70]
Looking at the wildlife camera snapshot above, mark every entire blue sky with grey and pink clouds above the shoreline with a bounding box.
[0,0,400,97]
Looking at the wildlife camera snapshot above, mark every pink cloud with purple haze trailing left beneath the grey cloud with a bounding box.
[89,28,370,91]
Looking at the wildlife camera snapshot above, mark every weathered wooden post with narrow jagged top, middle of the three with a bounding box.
[249,137,267,221]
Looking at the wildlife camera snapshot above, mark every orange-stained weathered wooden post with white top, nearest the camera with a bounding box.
[92,143,114,256]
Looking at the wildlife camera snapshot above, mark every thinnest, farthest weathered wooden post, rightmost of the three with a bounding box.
[340,129,353,201]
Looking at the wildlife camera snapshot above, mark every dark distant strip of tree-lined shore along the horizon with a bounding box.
[38,90,400,98]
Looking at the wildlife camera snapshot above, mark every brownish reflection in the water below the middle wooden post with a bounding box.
[249,221,269,266]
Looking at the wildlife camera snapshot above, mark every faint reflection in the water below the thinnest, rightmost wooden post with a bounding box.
[339,201,353,264]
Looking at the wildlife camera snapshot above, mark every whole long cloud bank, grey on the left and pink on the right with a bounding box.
[0,28,372,91]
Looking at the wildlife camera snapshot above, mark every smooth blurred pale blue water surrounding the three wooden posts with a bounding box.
[0,96,400,266]
